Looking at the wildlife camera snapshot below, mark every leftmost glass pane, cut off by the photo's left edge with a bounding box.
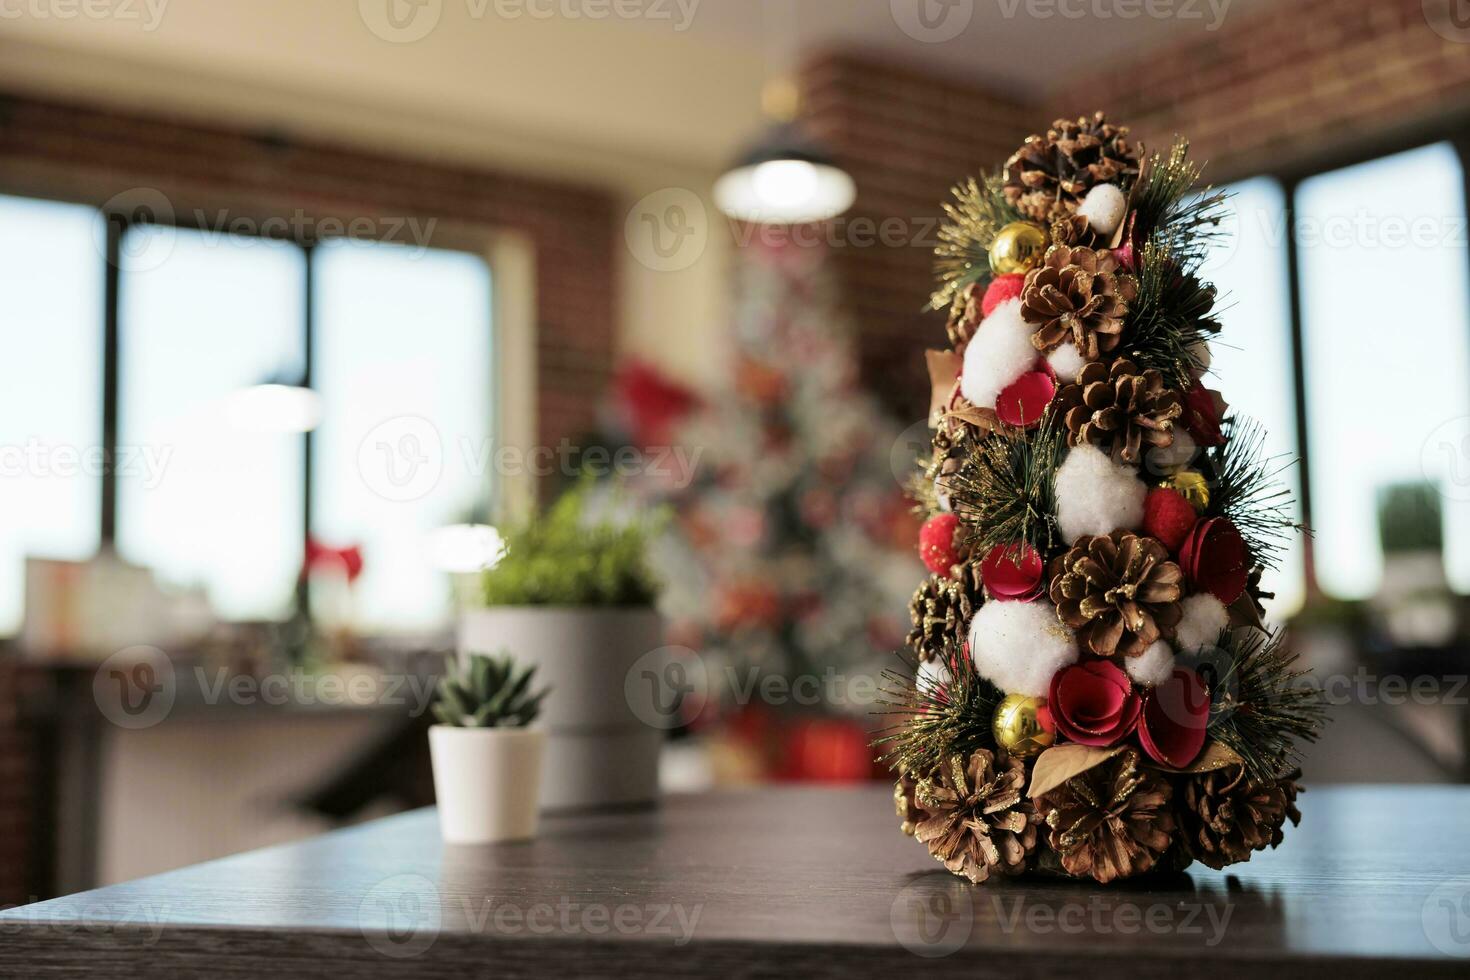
[0,197,104,635]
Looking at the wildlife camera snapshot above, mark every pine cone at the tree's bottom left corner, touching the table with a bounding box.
[914,749,1041,883]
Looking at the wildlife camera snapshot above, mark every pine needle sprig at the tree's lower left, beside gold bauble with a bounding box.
[873,652,1005,779]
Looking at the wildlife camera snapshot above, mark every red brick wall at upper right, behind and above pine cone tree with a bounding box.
[801,0,1470,419]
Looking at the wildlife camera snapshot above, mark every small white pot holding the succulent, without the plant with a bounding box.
[429,724,547,843]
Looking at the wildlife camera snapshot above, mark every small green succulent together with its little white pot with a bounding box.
[429,654,547,843]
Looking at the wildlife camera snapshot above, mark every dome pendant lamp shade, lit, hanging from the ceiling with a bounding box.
[714,123,857,225]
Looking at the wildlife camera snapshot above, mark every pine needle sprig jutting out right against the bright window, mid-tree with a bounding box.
[1205,416,1305,569]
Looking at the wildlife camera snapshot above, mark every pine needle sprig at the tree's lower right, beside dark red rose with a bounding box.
[1210,627,1327,780]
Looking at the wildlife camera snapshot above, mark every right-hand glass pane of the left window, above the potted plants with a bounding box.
[312,241,492,630]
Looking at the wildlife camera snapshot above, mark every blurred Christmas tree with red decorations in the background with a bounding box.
[622,244,920,776]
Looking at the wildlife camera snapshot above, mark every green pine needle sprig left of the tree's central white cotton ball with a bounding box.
[945,410,1066,555]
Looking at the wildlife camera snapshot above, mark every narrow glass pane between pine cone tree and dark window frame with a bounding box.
[1204,178,1305,620]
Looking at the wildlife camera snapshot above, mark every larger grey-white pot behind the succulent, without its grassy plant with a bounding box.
[459,605,664,810]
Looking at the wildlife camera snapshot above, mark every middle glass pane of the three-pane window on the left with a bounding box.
[118,226,306,619]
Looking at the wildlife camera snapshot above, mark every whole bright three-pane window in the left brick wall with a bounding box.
[0,197,492,635]
